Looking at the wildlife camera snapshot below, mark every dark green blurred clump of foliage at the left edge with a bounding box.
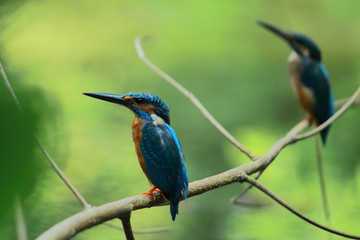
[0,64,52,239]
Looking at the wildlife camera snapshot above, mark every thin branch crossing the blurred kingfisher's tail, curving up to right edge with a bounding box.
[294,87,360,141]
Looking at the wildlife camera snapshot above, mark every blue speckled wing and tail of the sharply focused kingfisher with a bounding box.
[140,121,188,220]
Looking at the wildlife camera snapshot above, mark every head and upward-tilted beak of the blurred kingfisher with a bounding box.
[257,20,321,62]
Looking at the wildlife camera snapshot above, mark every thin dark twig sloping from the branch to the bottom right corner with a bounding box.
[243,174,360,239]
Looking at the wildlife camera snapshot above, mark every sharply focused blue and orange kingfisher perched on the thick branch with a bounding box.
[84,93,188,221]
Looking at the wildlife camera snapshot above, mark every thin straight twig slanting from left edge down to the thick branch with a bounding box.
[0,62,91,209]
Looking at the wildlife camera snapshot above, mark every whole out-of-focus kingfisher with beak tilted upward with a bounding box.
[257,20,335,145]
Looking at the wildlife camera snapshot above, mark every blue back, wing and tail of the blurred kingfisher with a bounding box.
[301,59,335,144]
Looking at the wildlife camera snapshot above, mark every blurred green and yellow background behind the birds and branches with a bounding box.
[0,0,360,240]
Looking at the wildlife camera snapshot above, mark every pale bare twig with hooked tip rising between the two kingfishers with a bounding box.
[134,36,257,160]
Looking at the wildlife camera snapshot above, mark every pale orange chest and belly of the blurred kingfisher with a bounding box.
[288,52,315,115]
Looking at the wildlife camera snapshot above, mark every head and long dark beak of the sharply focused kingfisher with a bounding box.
[84,93,170,124]
